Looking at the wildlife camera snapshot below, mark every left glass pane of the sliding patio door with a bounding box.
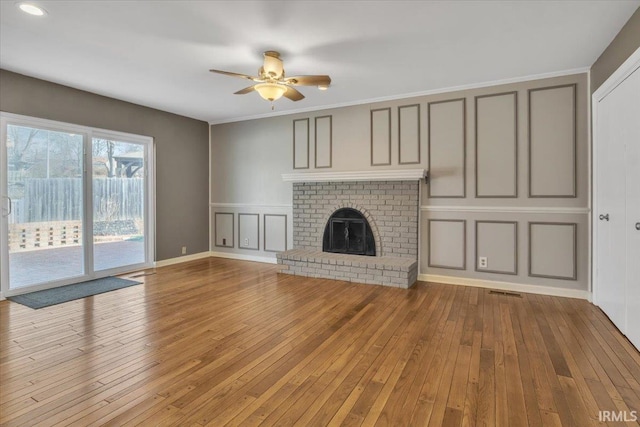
[6,124,85,290]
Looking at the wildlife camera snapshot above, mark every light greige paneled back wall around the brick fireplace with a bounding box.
[211,74,589,290]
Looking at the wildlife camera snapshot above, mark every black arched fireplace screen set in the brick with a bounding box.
[322,208,376,256]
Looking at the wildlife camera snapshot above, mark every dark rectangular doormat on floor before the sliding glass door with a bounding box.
[7,277,142,309]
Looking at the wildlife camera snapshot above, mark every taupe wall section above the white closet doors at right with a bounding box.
[591,8,640,93]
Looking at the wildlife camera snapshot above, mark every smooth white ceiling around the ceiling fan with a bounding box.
[0,0,640,123]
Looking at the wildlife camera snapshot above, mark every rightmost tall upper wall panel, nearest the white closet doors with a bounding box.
[529,84,577,197]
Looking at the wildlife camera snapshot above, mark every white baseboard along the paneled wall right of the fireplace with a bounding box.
[418,274,591,301]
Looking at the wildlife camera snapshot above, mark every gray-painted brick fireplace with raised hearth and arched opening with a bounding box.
[277,170,424,288]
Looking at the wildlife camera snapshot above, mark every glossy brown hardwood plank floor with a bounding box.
[0,258,640,426]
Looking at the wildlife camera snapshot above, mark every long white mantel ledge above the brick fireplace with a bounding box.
[282,169,427,182]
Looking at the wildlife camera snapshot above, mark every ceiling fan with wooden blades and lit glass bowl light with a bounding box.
[209,50,331,105]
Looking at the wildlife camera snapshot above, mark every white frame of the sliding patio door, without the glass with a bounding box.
[0,112,155,297]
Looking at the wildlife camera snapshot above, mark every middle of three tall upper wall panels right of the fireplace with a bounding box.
[475,92,518,197]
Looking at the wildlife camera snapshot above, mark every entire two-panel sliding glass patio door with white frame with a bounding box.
[0,113,153,296]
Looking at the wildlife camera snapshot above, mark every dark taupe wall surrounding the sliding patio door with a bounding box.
[0,70,209,260]
